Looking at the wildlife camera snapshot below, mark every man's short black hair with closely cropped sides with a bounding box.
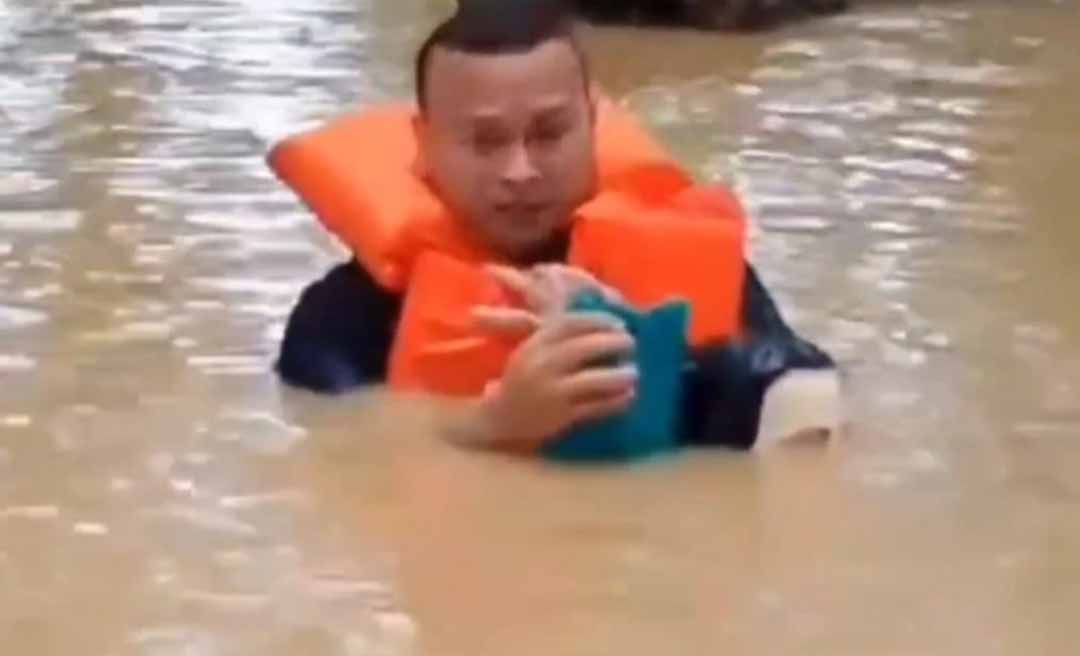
[415,0,589,111]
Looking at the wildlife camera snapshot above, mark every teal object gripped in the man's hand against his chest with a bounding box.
[544,291,690,460]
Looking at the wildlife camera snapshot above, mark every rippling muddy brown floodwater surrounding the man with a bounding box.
[0,0,1080,656]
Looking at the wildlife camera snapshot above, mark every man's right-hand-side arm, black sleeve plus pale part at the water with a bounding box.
[684,264,839,449]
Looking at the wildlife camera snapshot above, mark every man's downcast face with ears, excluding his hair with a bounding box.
[417,39,596,259]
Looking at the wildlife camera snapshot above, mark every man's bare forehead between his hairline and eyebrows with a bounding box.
[427,39,584,120]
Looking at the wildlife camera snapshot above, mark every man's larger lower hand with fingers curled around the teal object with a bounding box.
[468,312,637,451]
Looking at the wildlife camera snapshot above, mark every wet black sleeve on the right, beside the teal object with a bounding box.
[683,264,835,449]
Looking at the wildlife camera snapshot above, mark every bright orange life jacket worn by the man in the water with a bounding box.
[268,97,744,396]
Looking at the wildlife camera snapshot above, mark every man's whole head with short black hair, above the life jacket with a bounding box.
[416,0,596,262]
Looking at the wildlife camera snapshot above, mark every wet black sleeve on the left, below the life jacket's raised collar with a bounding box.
[278,260,401,393]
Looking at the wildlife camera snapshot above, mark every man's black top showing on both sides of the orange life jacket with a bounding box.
[278,262,834,449]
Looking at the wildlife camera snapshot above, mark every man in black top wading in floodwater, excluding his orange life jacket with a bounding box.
[278,0,833,449]
